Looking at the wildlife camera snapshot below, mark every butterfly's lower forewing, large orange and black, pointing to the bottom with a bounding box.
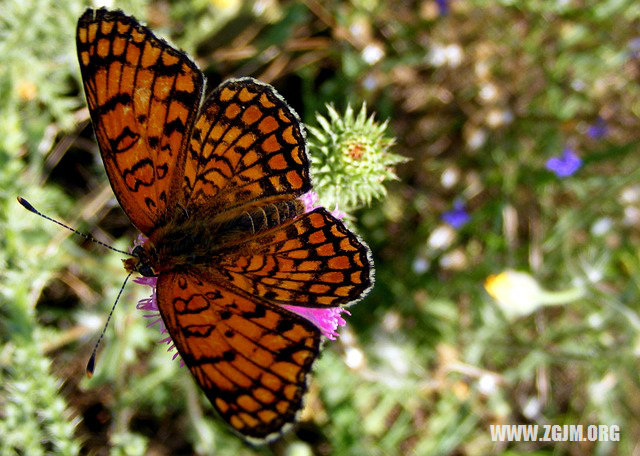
[157,270,320,443]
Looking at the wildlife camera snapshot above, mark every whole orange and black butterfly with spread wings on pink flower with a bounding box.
[77,9,373,443]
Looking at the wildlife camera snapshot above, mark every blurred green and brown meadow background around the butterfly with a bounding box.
[0,0,640,456]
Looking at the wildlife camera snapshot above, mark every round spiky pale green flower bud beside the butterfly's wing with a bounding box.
[307,103,407,212]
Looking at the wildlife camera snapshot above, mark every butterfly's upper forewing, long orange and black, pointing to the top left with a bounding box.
[76,9,204,235]
